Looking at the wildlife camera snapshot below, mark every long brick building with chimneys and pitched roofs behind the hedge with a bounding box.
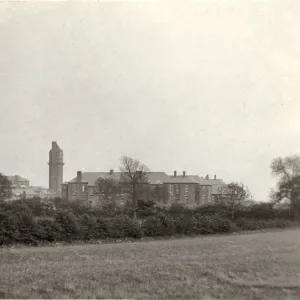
[62,170,227,206]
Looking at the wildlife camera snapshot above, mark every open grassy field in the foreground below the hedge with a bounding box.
[0,229,300,299]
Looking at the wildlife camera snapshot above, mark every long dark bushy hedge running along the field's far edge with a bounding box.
[0,198,295,245]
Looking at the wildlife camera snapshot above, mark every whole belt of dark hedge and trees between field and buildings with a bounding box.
[0,156,300,245]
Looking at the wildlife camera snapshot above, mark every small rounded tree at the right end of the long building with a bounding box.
[221,182,252,219]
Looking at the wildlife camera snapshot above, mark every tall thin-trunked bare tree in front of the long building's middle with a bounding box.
[120,156,149,220]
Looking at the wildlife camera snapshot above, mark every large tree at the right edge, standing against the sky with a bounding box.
[271,155,300,219]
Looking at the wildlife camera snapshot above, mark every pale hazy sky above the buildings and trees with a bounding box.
[0,0,300,201]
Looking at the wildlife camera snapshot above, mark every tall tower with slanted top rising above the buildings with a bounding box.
[48,142,64,192]
